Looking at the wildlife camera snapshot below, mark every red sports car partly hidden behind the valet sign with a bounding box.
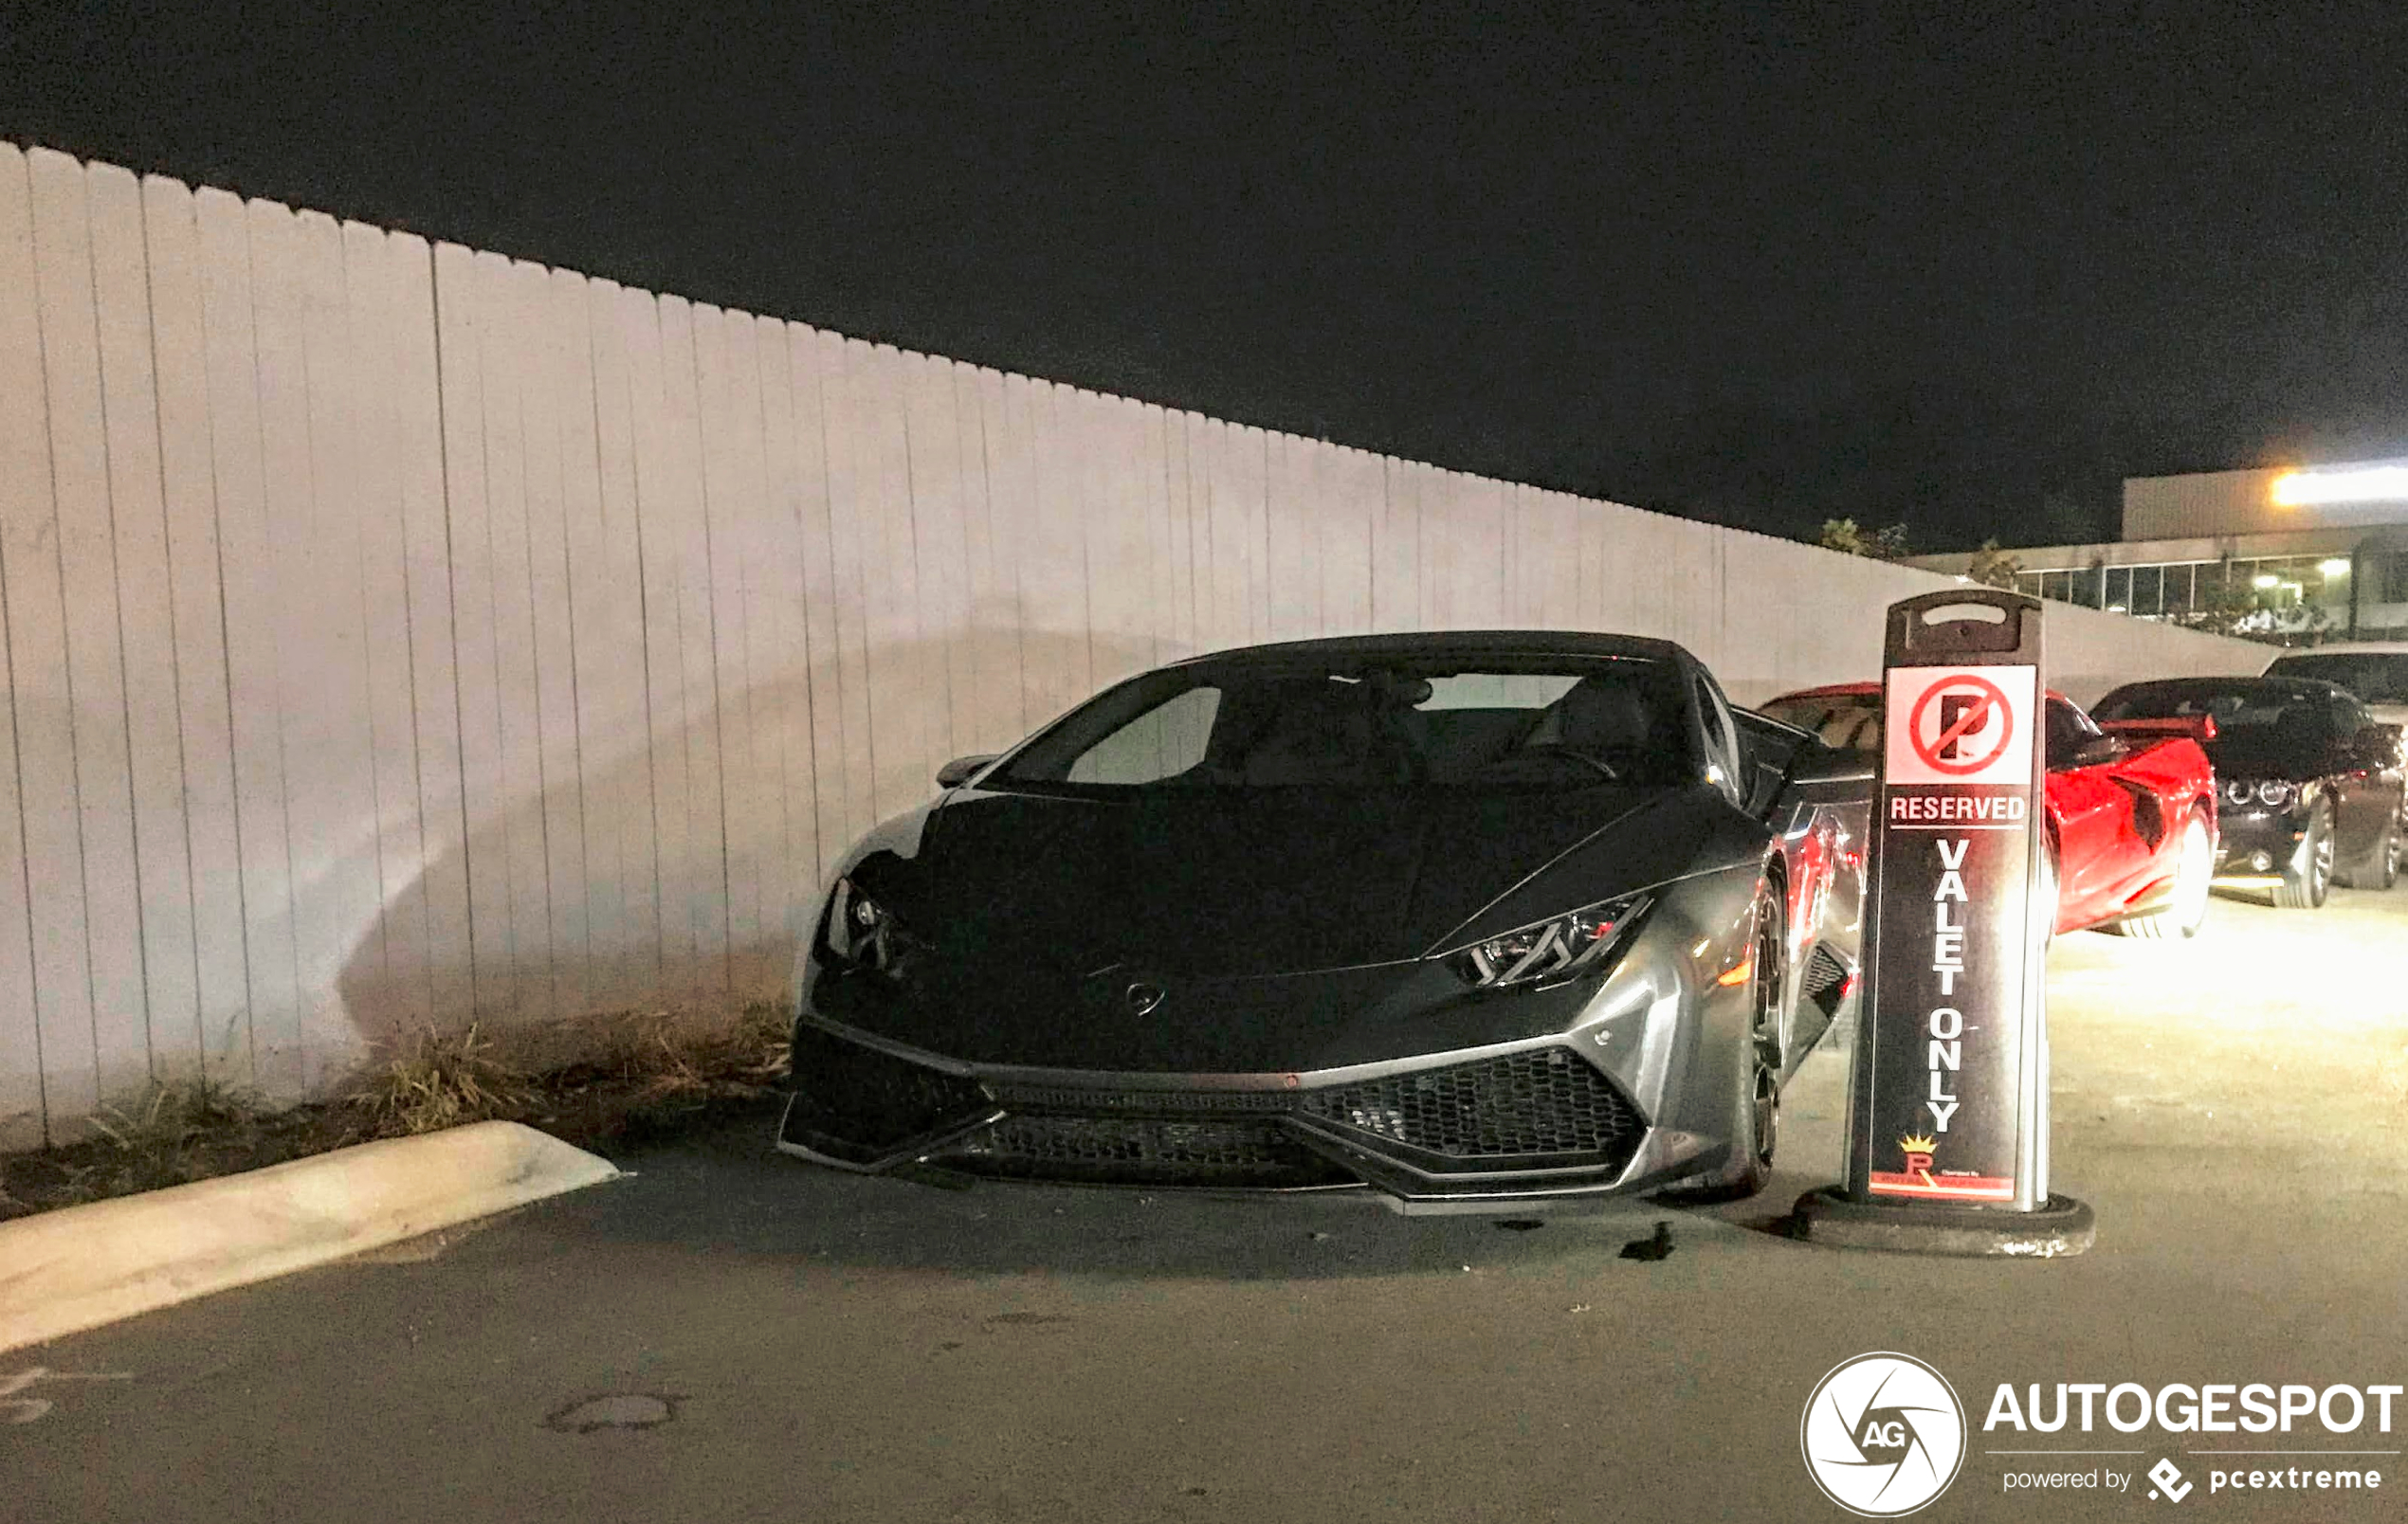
[1758,683,2216,936]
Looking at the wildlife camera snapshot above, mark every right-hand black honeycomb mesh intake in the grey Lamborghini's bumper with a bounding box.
[1303,1047,1647,1165]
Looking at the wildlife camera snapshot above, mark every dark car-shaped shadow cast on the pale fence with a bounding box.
[332,628,1158,1061]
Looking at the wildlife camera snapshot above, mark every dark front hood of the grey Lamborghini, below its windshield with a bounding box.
[852,788,1683,977]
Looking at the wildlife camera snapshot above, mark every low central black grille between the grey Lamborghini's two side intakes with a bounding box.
[935,1113,1353,1189]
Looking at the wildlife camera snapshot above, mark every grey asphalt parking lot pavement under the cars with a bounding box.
[0,886,2408,1524]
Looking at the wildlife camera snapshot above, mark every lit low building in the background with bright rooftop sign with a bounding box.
[1907,460,2408,643]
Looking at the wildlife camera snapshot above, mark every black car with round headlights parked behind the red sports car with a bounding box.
[2090,677,2400,910]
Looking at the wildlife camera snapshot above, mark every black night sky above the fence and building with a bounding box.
[0,0,2408,549]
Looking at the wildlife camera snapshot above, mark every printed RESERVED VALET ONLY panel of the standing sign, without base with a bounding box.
[1852,664,2047,1208]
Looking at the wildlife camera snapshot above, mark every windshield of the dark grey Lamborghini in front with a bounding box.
[987,655,1700,792]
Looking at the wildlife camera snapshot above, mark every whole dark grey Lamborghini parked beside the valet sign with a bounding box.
[780,631,1856,1211]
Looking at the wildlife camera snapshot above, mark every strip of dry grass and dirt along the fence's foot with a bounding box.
[0,1002,788,1218]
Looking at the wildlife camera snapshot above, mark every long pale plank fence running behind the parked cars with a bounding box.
[0,144,2261,1141]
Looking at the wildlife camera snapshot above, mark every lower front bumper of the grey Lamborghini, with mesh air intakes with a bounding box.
[777,1019,1714,1213]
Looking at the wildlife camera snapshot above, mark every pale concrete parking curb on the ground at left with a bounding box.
[0,1122,619,1351]
